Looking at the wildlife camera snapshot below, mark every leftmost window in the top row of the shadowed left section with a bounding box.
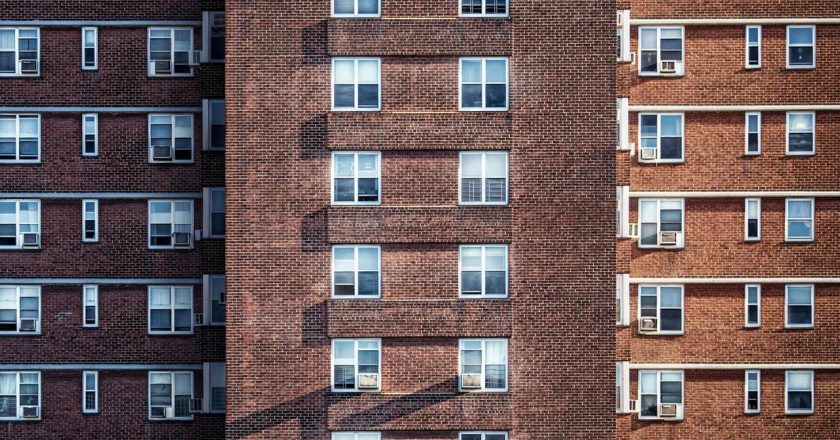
[0,28,40,76]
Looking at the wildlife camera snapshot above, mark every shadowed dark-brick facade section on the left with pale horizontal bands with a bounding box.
[0,0,225,439]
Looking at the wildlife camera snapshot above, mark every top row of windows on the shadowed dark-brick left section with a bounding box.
[0,12,225,77]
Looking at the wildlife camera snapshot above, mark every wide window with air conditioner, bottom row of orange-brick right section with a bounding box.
[639,370,683,420]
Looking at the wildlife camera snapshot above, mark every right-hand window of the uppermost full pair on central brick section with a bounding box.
[459,58,508,111]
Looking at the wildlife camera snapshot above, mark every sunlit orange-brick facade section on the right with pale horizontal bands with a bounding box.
[616,0,840,439]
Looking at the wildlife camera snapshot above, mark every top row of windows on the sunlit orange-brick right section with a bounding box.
[616,20,817,72]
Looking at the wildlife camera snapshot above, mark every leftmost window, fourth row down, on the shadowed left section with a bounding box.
[0,286,41,335]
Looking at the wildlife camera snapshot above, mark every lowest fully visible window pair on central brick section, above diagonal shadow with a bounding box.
[332,339,508,393]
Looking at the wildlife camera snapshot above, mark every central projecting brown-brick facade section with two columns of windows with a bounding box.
[226,0,615,440]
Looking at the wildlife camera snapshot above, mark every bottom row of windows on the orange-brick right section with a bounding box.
[616,368,814,420]
